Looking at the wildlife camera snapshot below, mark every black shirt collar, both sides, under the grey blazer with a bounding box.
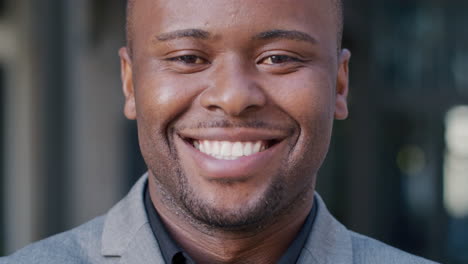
[145,188,317,264]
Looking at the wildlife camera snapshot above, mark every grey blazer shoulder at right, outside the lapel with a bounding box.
[349,231,435,264]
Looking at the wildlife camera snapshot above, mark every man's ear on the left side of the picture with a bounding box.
[119,47,136,120]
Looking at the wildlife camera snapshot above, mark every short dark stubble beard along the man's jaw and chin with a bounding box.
[148,125,313,232]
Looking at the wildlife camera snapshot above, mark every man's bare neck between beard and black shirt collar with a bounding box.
[149,180,314,264]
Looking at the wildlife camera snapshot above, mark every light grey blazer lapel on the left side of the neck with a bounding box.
[101,174,164,264]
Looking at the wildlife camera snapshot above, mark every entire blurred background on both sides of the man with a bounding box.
[0,0,468,264]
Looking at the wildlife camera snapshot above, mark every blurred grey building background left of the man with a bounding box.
[0,0,144,255]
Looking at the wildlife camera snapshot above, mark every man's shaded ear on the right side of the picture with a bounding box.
[335,49,351,120]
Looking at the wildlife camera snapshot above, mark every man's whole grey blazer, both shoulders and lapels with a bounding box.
[0,175,434,264]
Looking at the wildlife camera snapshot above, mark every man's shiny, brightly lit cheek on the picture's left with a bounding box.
[135,67,205,168]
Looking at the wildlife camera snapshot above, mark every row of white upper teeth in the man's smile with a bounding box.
[193,140,267,160]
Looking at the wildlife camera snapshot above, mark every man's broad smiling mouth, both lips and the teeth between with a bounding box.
[175,128,290,182]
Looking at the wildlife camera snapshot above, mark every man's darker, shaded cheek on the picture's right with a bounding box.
[271,69,334,169]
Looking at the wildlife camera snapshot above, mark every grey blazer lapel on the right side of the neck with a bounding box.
[297,193,353,264]
